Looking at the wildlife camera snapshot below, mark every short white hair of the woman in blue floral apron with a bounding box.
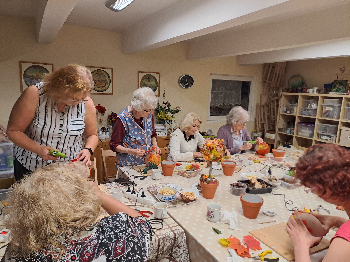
[131,87,158,111]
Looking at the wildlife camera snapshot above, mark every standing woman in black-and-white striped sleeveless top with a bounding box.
[7,64,98,181]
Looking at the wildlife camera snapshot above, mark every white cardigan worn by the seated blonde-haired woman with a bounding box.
[168,128,204,162]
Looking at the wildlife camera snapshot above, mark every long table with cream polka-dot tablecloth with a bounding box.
[119,152,347,262]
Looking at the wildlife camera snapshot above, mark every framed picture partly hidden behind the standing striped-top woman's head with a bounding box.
[86,66,113,95]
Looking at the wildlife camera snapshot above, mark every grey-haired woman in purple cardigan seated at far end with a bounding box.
[217,106,263,154]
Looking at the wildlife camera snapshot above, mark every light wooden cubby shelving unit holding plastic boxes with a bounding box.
[275,93,350,148]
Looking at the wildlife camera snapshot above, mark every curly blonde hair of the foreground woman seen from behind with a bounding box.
[5,163,101,257]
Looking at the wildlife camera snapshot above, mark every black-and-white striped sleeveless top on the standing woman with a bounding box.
[14,83,85,171]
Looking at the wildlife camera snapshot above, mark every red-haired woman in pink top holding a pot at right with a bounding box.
[287,144,350,262]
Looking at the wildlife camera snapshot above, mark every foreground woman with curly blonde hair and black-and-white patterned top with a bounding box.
[5,162,152,262]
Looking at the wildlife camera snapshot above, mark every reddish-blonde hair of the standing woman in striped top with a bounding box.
[42,64,94,99]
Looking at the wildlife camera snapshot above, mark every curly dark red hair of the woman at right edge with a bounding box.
[296,144,350,200]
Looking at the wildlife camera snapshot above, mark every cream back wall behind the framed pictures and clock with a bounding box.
[0,16,262,133]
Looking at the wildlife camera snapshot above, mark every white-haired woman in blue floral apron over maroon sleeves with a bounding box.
[109,87,160,166]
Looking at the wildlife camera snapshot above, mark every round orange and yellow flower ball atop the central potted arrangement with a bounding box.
[201,138,227,162]
